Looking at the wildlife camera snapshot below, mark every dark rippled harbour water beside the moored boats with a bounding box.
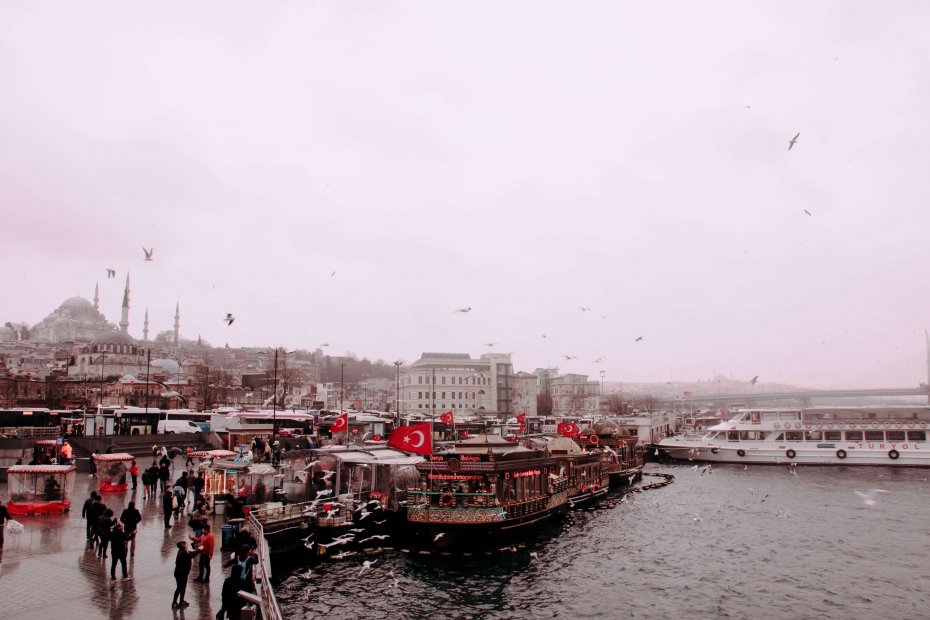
[276,464,930,619]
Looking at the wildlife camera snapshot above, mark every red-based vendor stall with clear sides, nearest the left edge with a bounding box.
[7,465,77,515]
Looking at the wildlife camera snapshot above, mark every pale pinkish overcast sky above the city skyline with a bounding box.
[0,0,930,387]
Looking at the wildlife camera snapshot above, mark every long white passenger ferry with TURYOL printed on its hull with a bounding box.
[656,407,930,467]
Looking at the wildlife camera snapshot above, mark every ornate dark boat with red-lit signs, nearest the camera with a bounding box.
[407,435,569,548]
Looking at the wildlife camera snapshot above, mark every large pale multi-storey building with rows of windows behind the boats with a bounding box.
[400,353,514,416]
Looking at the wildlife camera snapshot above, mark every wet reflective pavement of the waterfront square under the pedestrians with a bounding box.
[0,457,229,620]
